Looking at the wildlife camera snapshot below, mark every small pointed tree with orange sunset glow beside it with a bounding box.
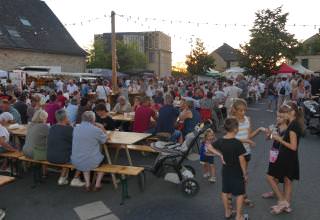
[186,38,215,75]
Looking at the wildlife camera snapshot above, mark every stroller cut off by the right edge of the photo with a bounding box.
[303,100,320,135]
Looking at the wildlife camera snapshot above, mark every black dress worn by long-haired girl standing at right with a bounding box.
[272,121,301,183]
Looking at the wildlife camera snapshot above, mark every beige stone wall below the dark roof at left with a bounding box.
[0,49,86,73]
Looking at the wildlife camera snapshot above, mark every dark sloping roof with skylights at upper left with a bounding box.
[0,0,86,56]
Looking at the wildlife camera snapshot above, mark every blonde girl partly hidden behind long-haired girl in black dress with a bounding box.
[262,111,289,199]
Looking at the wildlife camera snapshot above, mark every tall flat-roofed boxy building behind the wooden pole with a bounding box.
[94,31,172,77]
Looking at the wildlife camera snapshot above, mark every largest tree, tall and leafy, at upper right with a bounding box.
[240,7,300,75]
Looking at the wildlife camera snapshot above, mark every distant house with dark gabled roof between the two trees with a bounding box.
[210,43,239,72]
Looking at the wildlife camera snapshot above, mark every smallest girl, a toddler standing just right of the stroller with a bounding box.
[200,129,216,183]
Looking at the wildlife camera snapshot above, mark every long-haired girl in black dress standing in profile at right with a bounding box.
[269,102,303,214]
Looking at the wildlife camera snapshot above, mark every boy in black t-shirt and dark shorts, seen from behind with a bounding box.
[213,118,248,220]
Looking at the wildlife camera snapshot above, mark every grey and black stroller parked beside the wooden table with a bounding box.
[144,124,212,196]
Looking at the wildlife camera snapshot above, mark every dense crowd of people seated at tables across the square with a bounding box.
[0,73,311,189]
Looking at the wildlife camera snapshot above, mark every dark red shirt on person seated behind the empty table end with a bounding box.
[133,105,156,133]
